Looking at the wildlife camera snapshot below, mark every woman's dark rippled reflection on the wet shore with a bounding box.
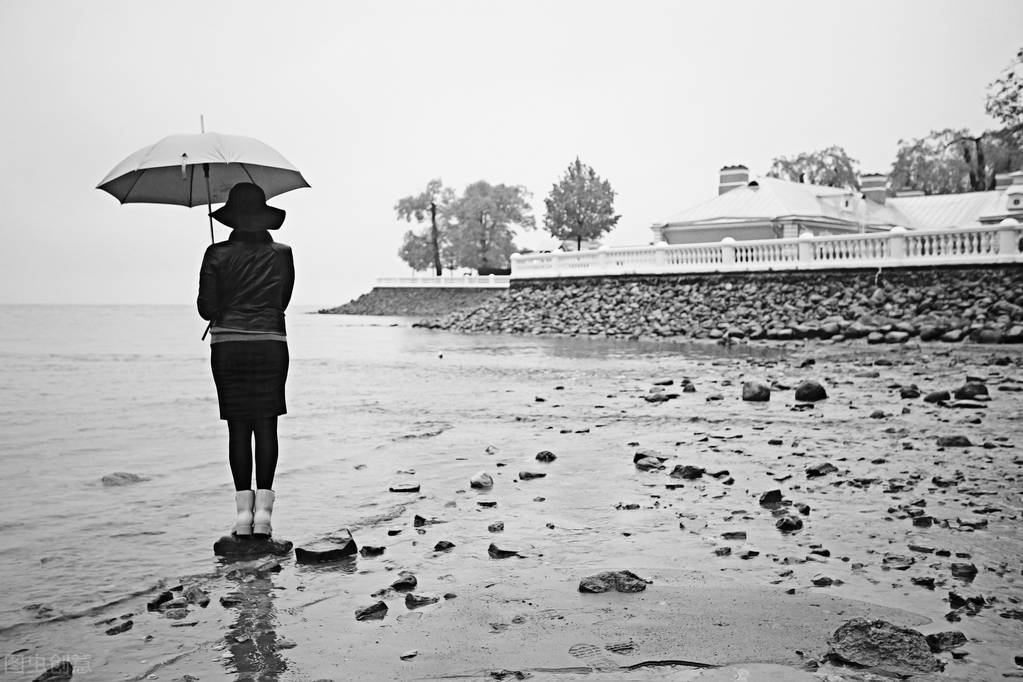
[224,572,287,682]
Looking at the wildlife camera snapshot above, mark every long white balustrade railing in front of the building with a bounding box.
[512,225,1023,279]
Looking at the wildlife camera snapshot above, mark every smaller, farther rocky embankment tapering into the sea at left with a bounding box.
[319,287,503,315]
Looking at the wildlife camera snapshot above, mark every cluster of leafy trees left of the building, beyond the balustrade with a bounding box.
[394,158,620,276]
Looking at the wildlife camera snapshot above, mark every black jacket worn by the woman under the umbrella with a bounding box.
[196,230,295,334]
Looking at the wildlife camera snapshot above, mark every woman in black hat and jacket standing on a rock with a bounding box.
[196,182,295,536]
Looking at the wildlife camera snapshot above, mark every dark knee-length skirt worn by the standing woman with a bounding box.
[210,340,288,419]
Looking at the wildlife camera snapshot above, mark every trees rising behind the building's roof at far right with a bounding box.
[767,48,1023,195]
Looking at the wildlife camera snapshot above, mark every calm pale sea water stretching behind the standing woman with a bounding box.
[0,306,769,639]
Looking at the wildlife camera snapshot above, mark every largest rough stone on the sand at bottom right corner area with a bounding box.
[829,618,940,677]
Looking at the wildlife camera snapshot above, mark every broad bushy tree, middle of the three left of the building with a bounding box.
[448,180,535,270]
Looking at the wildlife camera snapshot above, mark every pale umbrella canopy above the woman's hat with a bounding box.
[96,133,309,207]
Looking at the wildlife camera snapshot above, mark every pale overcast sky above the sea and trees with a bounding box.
[0,0,1023,306]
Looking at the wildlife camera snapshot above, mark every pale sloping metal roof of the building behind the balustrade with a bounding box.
[657,178,1019,230]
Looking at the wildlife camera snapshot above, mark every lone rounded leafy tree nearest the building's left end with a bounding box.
[543,156,621,251]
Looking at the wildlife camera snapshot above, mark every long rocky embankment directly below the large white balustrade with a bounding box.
[417,266,1023,344]
